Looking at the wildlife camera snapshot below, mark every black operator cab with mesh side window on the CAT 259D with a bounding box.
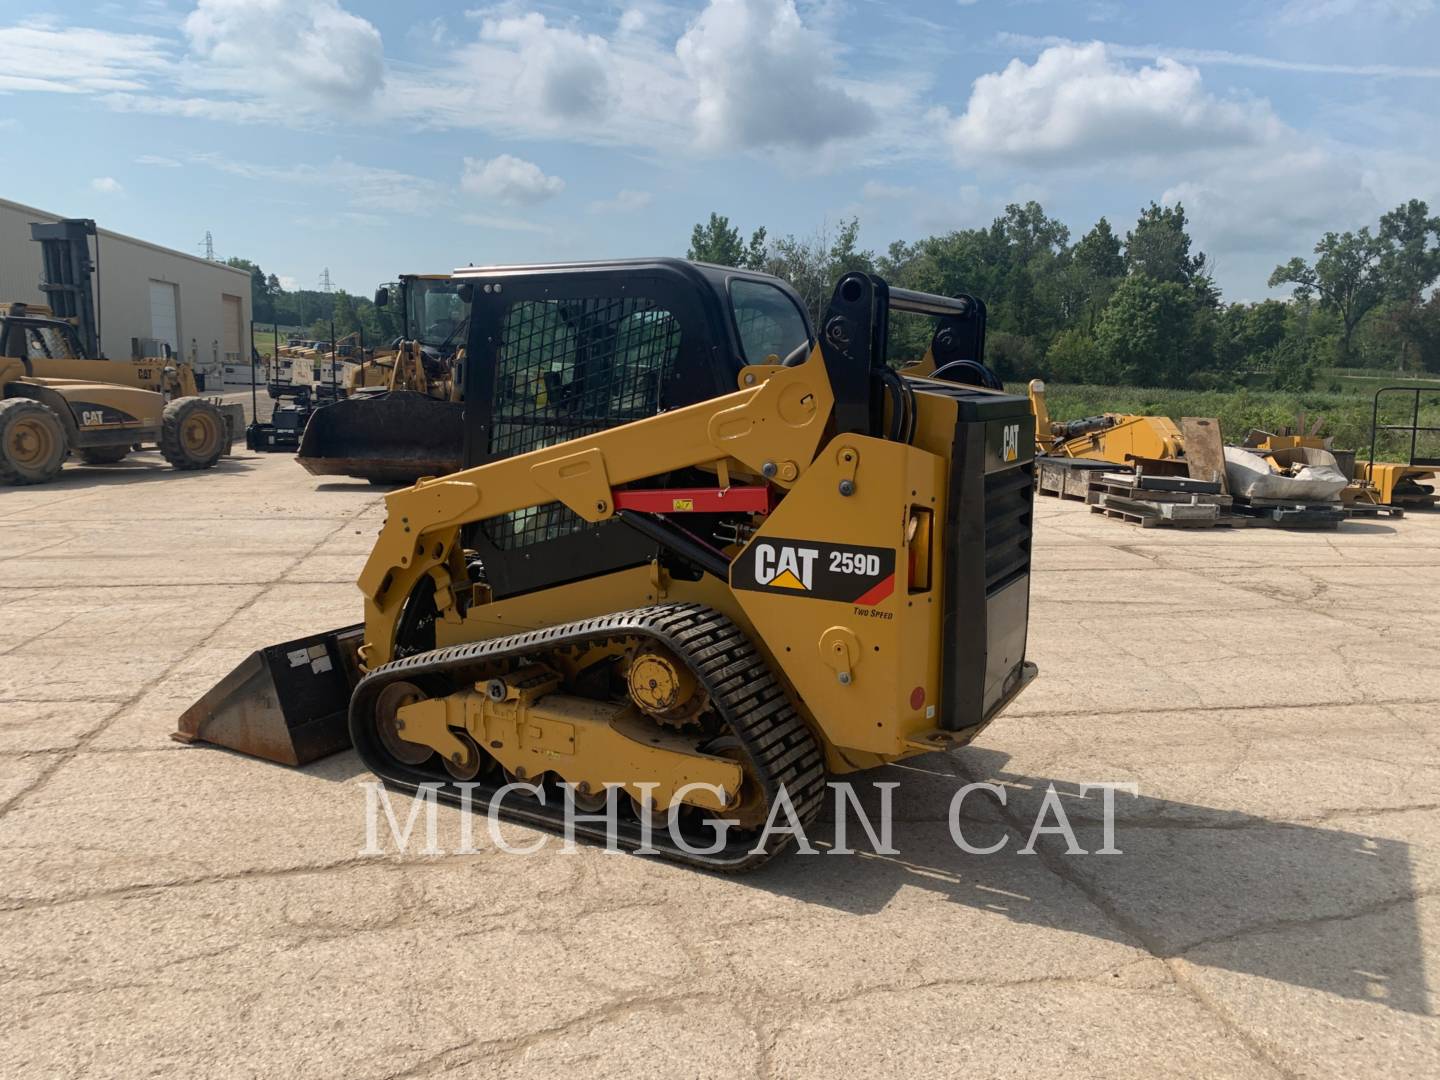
[446,259,815,595]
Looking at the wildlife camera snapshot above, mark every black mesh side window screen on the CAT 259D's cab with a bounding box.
[482,297,680,549]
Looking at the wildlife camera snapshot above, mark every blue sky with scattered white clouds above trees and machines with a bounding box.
[0,0,1440,300]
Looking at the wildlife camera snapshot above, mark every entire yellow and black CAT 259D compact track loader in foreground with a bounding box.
[177,259,1034,870]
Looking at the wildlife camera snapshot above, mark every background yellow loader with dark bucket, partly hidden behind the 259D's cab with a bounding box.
[297,274,468,484]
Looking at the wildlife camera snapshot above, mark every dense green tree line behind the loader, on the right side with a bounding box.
[687,199,1440,390]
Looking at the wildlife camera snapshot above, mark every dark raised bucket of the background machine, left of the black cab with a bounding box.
[297,390,465,484]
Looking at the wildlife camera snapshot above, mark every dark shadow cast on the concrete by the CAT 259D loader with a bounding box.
[754,747,1430,1014]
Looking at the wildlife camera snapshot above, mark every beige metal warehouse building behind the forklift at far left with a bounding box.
[0,199,251,386]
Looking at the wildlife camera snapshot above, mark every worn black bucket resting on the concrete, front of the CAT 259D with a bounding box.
[171,624,364,765]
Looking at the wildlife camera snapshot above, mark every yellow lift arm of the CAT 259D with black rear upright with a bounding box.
[359,272,985,667]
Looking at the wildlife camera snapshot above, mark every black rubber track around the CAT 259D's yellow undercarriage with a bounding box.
[350,603,825,871]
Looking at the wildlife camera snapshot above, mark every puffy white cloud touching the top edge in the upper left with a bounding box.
[184,0,384,108]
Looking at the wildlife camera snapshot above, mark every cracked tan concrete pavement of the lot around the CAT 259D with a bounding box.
[0,452,1440,1077]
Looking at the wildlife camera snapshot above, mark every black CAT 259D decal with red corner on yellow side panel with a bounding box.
[730,537,896,606]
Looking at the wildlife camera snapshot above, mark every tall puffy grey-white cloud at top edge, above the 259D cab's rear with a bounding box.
[675,0,877,150]
